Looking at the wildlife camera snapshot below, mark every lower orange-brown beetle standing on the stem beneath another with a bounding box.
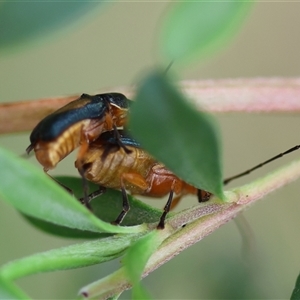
[75,130,211,229]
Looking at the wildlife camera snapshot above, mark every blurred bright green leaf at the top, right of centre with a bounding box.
[160,1,252,63]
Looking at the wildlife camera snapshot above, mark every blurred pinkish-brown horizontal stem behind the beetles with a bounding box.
[0,78,300,134]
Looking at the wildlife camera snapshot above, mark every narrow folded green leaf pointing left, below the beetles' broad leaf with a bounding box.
[0,234,137,280]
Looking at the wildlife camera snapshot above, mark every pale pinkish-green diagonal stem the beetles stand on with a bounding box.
[81,160,300,299]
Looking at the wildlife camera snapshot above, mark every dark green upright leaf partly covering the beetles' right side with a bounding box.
[129,73,224,199]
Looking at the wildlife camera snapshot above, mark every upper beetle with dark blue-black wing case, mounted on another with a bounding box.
[26,93,130,172]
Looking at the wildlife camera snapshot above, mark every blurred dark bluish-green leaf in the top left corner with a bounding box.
[0,0,101,52]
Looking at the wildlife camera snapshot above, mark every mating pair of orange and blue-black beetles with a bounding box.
[26,93,210,228]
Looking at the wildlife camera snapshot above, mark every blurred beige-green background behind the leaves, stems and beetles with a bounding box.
[0,2,300,299]
